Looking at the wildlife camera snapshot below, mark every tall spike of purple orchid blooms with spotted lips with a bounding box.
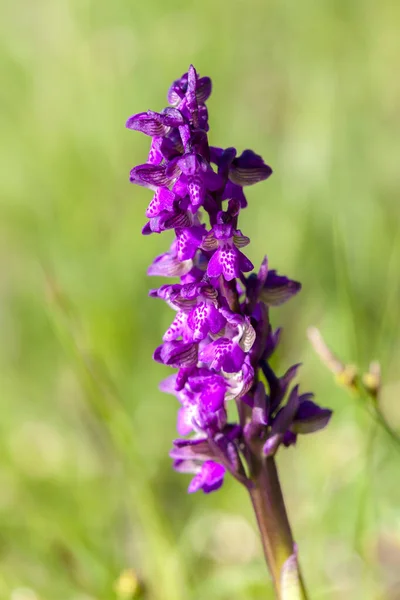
[126,66,331,493]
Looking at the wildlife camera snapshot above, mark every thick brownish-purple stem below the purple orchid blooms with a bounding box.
[249,457,307,600]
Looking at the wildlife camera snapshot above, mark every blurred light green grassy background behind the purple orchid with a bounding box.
[0,0,400,600]
